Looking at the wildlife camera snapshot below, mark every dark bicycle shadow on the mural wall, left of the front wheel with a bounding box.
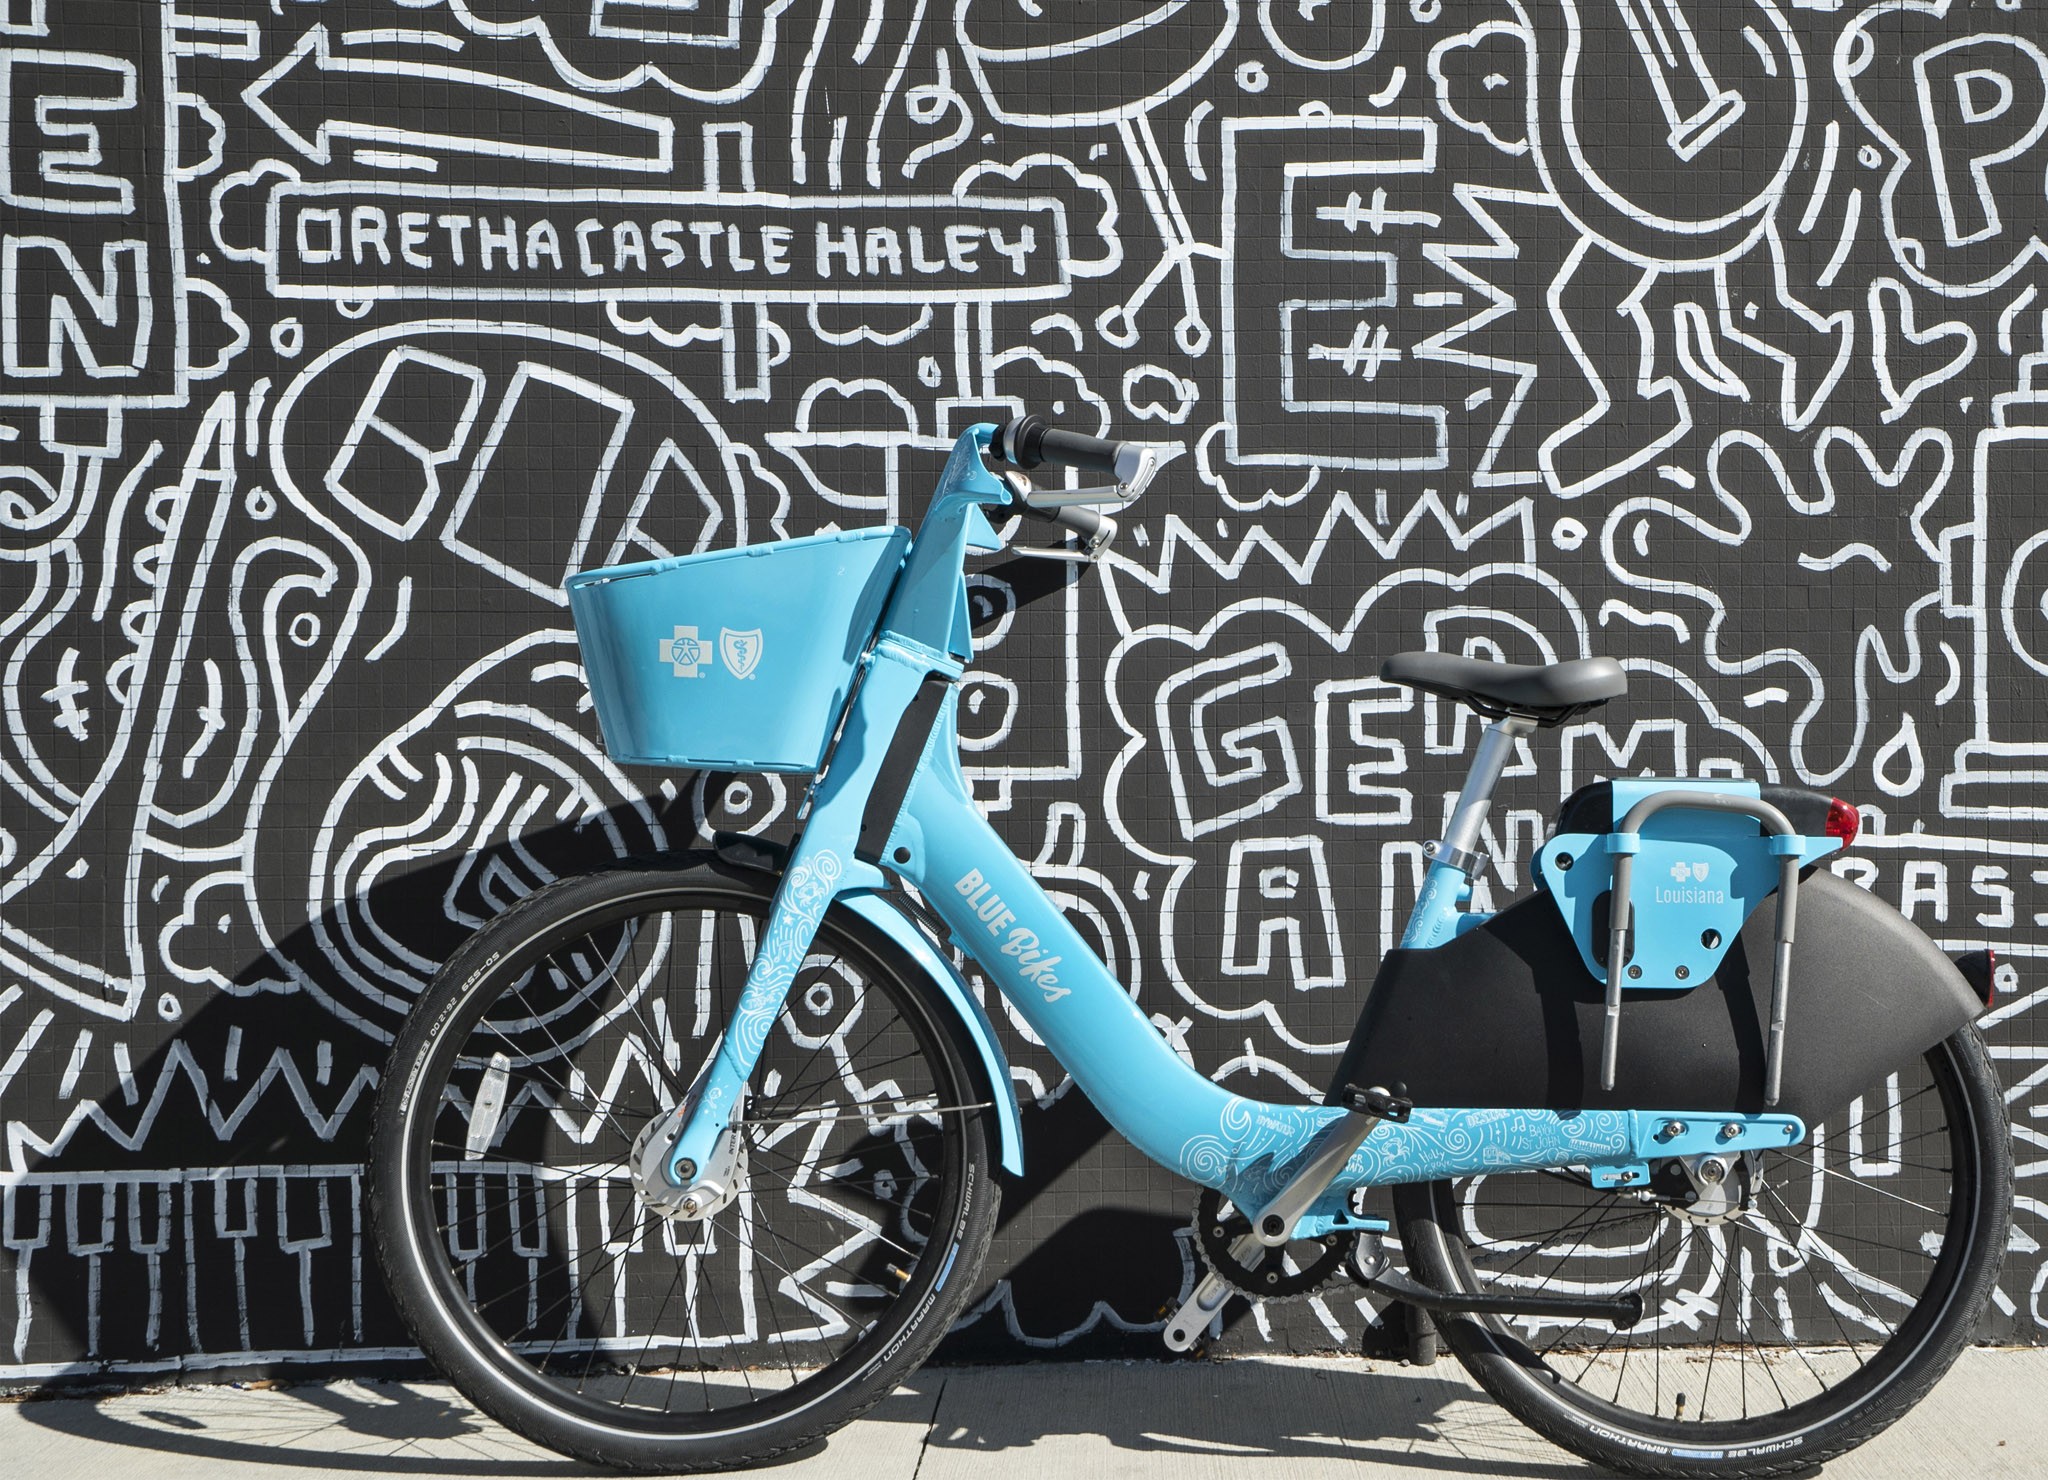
[0,798,712,1390]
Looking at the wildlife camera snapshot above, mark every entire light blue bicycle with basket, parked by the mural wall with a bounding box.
[371,418,2011,1476]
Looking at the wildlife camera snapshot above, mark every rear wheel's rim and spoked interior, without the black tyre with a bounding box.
[1434,1044,1985,1451]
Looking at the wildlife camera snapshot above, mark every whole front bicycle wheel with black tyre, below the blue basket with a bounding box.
[369,858,1008,1472]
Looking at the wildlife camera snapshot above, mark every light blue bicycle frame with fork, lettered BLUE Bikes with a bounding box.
[670,424,1806,1234]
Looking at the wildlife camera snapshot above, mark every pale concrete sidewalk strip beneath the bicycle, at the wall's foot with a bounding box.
[0,1351,2048,1480]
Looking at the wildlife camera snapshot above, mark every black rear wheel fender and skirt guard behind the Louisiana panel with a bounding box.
[1331,868,1985,1126]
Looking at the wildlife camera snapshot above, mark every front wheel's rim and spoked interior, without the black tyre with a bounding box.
[395,890,979,1435]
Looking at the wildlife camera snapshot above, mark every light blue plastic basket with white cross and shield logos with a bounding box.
[565,528,909,774]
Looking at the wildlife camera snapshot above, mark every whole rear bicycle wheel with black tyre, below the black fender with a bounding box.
[1395,1028,2013,1480]
